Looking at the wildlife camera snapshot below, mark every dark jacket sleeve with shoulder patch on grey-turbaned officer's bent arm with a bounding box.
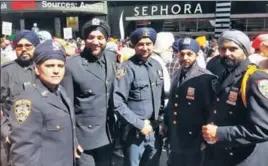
[217,79,268,145]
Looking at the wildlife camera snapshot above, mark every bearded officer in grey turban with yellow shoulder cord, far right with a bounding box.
[202,30,268,166]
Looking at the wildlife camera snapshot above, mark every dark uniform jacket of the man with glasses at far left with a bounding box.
[1,60,35,138]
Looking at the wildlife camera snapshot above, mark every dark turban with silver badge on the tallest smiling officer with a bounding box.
[82,18,110,39]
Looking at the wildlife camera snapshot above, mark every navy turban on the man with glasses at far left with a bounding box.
[13,29,40,47]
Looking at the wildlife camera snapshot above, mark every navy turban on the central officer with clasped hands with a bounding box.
[130,28,157,46]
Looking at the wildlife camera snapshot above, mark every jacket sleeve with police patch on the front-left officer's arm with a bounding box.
[10,100,43,166]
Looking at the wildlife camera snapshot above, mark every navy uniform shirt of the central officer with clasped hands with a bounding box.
[114,55,164,135]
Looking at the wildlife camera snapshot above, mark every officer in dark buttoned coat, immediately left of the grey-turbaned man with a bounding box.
[165,38,217,166]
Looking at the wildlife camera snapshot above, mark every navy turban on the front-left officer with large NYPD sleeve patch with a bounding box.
[33,40,66,64]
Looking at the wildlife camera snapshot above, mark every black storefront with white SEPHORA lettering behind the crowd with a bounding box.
[108,1,268,38]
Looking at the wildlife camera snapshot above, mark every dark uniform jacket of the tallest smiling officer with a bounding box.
[62,51,116,150]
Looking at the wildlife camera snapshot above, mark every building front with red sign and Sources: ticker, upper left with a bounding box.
[1,0,108,37]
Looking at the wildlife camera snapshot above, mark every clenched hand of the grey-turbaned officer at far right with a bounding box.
[202,124,218,144]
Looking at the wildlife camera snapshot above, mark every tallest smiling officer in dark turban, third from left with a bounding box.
[62,18,116,166]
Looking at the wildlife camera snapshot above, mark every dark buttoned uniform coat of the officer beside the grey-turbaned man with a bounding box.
[165,64,217,153]
